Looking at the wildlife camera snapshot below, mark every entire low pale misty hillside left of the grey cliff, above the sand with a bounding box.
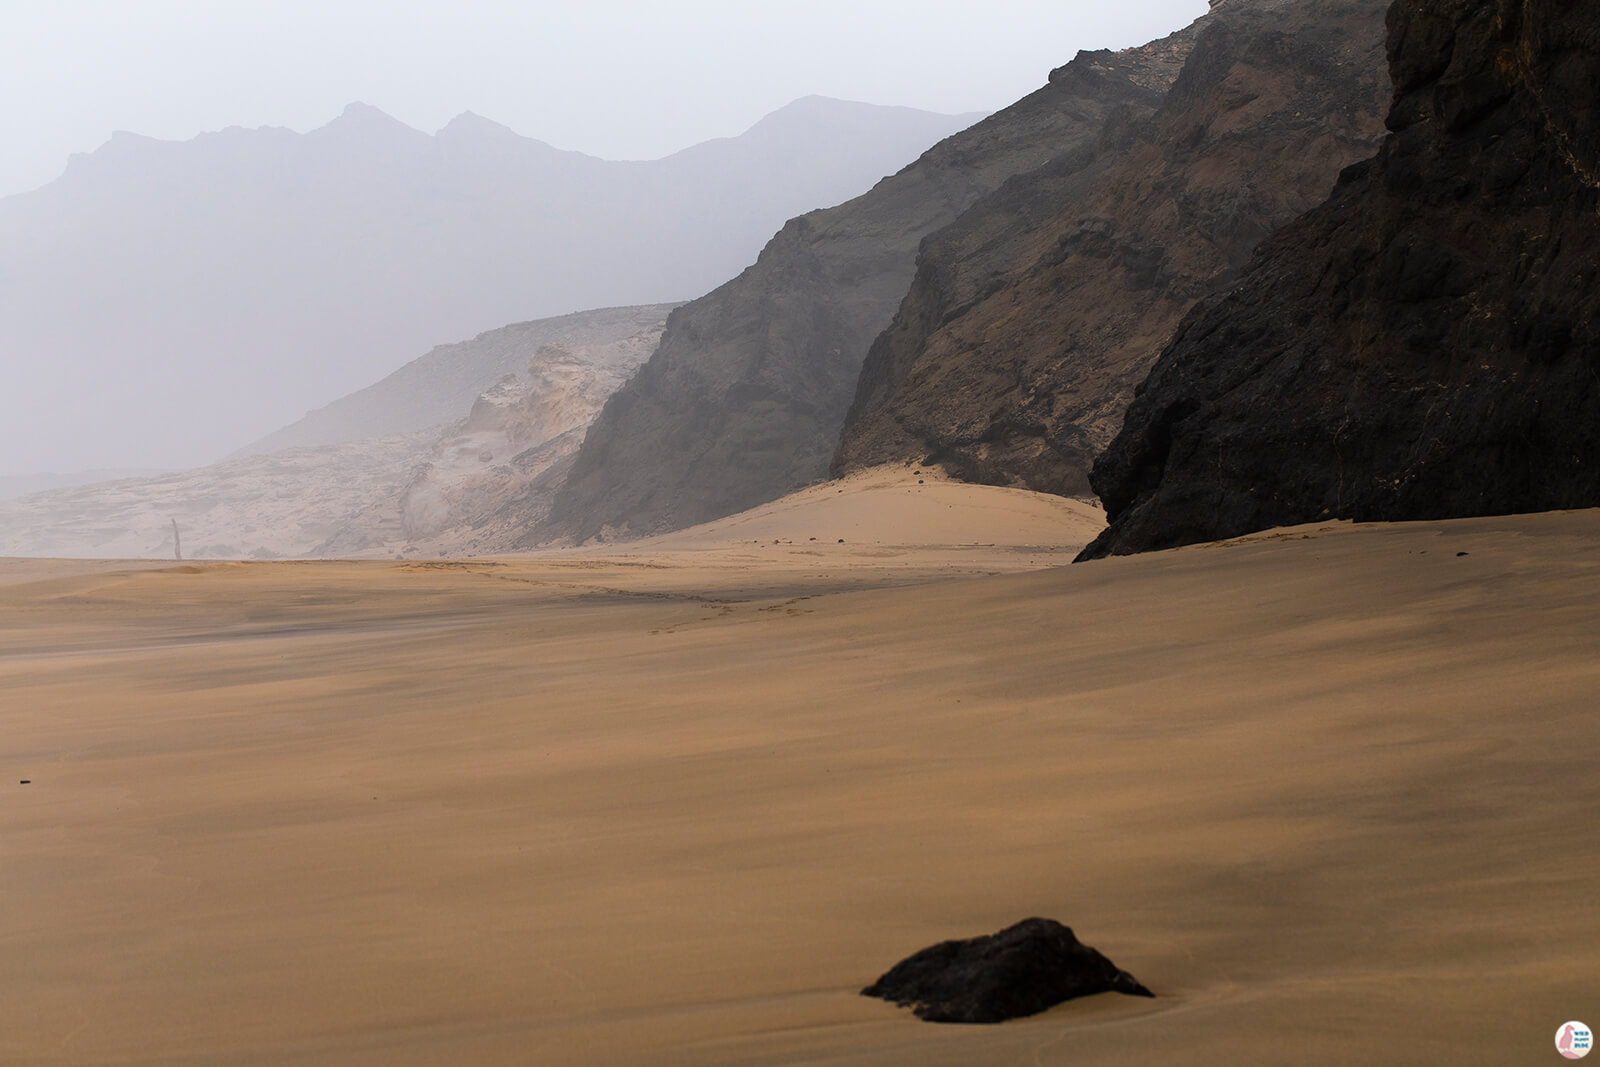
[0,307,666,558]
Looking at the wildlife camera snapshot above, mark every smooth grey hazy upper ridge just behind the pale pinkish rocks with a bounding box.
[237,304,677,456]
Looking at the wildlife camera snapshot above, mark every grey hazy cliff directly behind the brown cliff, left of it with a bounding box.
[546,32,1192,539]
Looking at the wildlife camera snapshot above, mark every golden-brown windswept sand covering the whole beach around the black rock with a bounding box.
[0,472,1600,1065]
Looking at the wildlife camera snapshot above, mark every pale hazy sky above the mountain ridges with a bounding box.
[0,0,1206,195]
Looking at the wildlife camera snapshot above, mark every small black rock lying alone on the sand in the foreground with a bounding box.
[861,918,1155,1022]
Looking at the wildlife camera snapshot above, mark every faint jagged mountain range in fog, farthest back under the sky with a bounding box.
[0,98,978,475]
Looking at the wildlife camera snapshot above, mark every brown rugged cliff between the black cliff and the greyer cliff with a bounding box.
[832,0,1389,496]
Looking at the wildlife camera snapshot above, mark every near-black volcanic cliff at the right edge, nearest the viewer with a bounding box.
[1085,0,1600,558]
